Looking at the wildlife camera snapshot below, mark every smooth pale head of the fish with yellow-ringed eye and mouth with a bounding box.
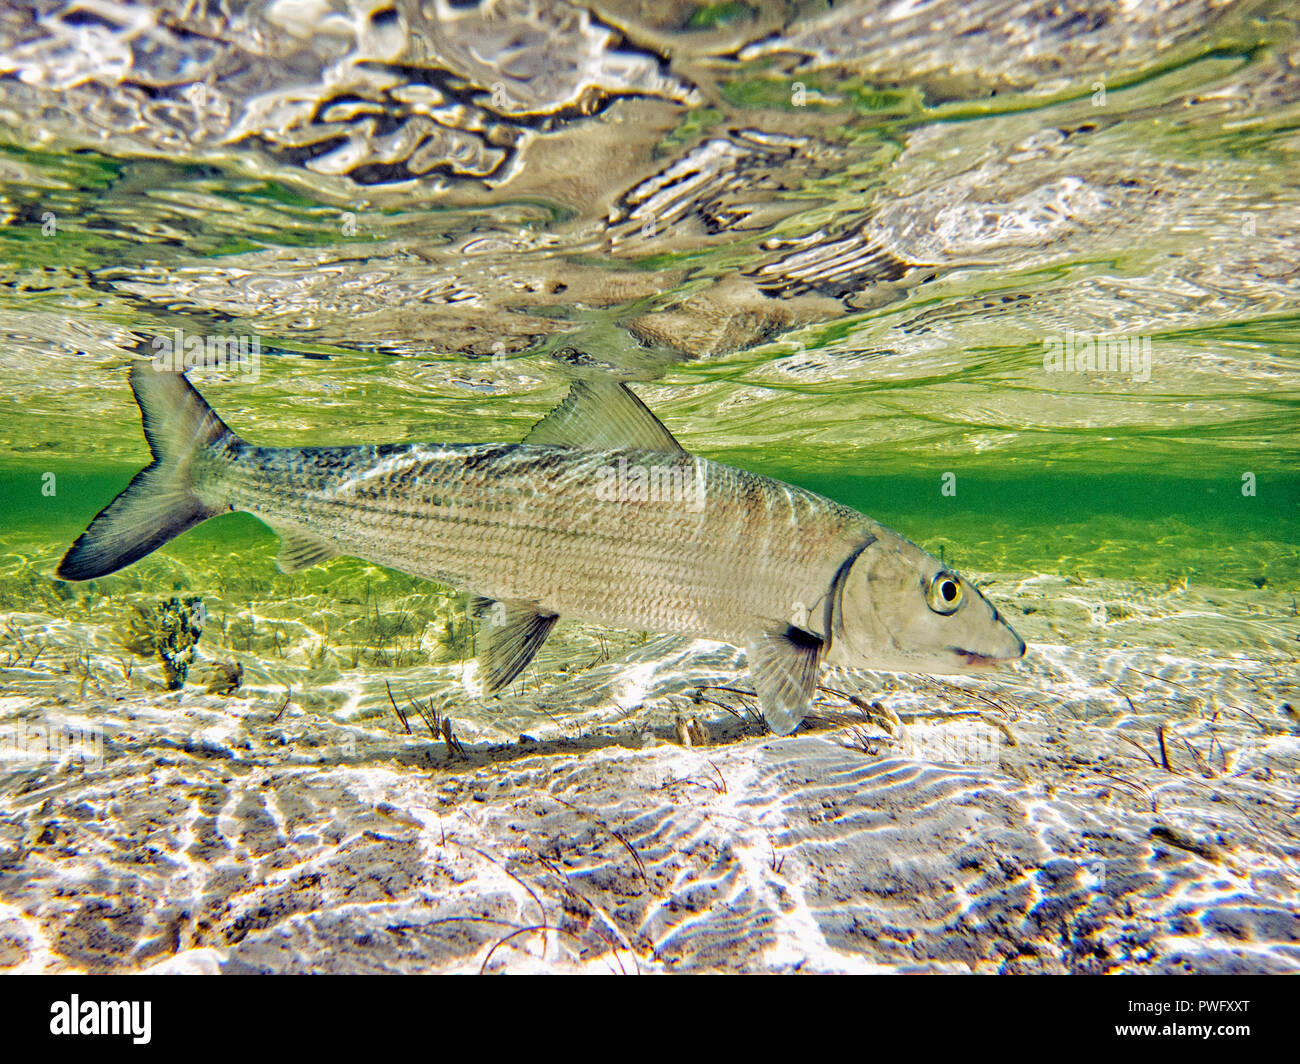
[829,529,1024,674]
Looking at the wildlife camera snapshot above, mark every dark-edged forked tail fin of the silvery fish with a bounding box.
[55,362,238,580]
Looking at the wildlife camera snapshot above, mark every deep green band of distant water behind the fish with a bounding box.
[0,463,1300,594]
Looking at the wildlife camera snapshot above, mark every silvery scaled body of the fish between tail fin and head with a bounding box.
[210,445,874,640]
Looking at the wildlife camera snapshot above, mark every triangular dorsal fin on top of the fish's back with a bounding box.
[524,380,685,454]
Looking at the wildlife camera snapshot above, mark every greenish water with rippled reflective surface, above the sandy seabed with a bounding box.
[0,3,1300,681]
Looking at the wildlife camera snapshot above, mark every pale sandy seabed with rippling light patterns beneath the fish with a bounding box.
[0,576,1300,973]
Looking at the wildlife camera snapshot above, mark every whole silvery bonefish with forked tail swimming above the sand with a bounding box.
[57,360,1024,735]
